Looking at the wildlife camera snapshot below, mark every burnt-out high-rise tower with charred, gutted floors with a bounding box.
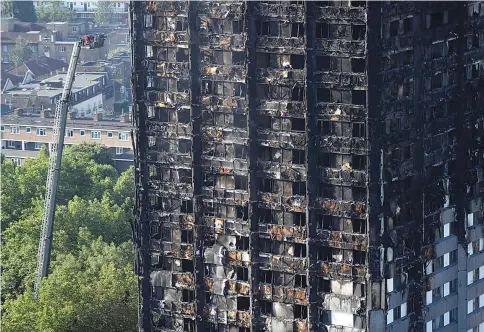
[131,1,484,332]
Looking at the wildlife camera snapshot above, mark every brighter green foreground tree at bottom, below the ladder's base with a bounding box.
[1,233,138,332]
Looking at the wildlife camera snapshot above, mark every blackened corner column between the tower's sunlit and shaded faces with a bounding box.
[366,1,386,331]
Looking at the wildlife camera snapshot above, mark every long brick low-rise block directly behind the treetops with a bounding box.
[0,111,133,171]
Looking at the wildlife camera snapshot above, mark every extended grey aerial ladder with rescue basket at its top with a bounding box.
[34,35,104,298]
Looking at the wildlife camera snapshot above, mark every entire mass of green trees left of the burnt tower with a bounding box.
[1,144,137,332]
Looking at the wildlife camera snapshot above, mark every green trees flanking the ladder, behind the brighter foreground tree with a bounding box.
[0,144,134,298]
